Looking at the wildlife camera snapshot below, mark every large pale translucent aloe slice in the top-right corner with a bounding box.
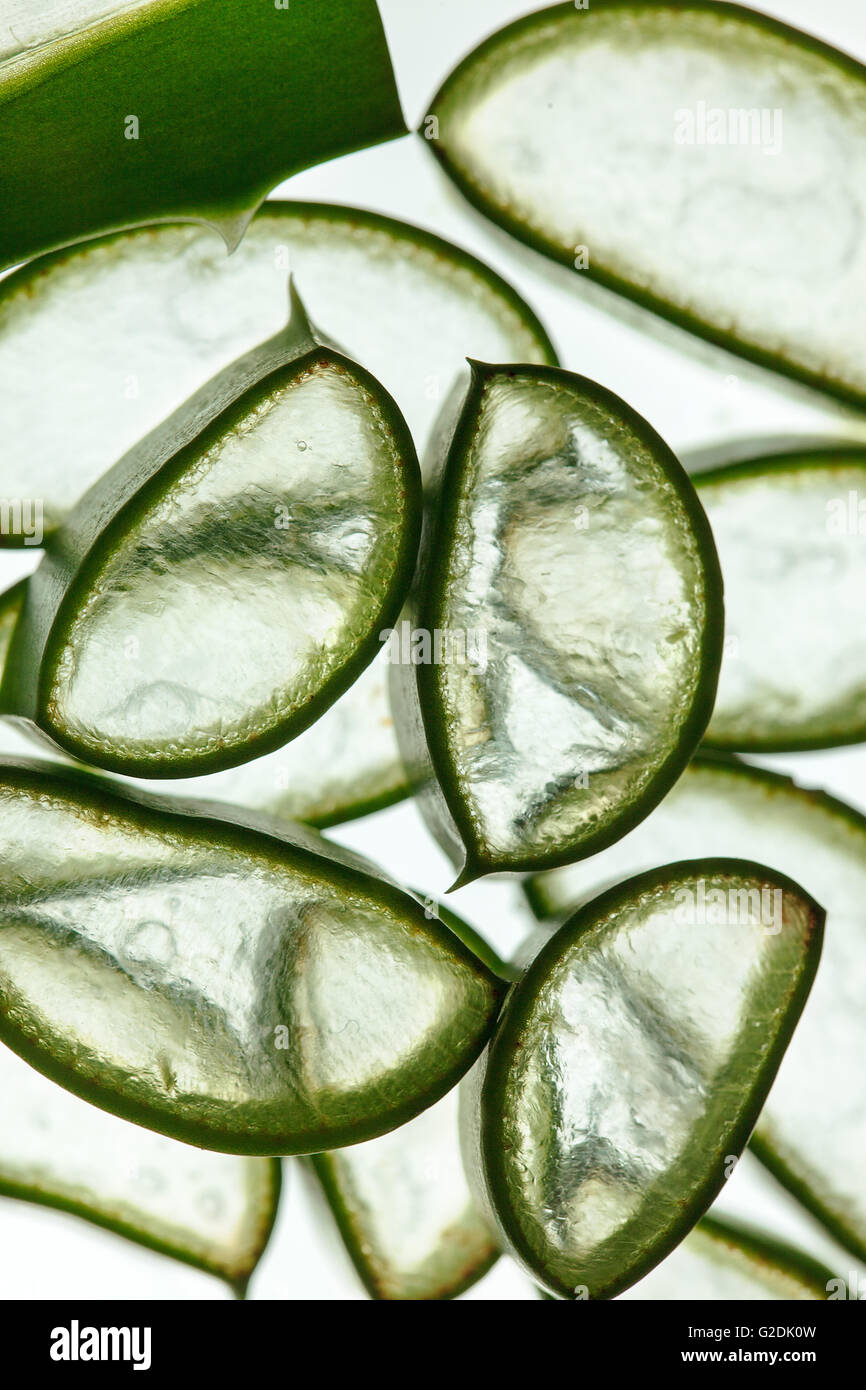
[425,0,866,404]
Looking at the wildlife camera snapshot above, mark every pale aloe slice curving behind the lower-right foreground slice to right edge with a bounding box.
[527,758,866,1259]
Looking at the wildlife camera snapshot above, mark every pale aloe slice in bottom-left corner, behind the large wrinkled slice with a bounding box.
[0,1047,281,1293]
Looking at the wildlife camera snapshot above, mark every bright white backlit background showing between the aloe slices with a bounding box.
[0,0,866,1298]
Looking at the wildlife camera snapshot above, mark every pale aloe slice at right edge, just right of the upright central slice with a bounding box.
[694,448,866,752]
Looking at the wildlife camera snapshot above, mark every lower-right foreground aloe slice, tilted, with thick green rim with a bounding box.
[466,859,824,1298]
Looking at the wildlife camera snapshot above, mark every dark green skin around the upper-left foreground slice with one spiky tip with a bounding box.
[0,291,421,778]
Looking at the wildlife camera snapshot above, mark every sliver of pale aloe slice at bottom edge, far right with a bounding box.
[623,1216,834,1302]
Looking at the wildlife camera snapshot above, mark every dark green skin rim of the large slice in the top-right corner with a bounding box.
[424,0,866,410]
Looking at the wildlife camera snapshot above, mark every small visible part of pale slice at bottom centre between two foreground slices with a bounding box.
[313,1088,499,1300]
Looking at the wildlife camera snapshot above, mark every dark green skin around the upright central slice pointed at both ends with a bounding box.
[391,363,724,888]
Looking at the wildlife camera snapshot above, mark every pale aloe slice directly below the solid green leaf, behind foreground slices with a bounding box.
[0,202,556,546]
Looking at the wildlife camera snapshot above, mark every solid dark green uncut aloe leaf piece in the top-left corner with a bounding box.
[0,0,406,268]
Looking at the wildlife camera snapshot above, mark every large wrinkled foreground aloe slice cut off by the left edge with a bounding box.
[0,762,499,1155]
